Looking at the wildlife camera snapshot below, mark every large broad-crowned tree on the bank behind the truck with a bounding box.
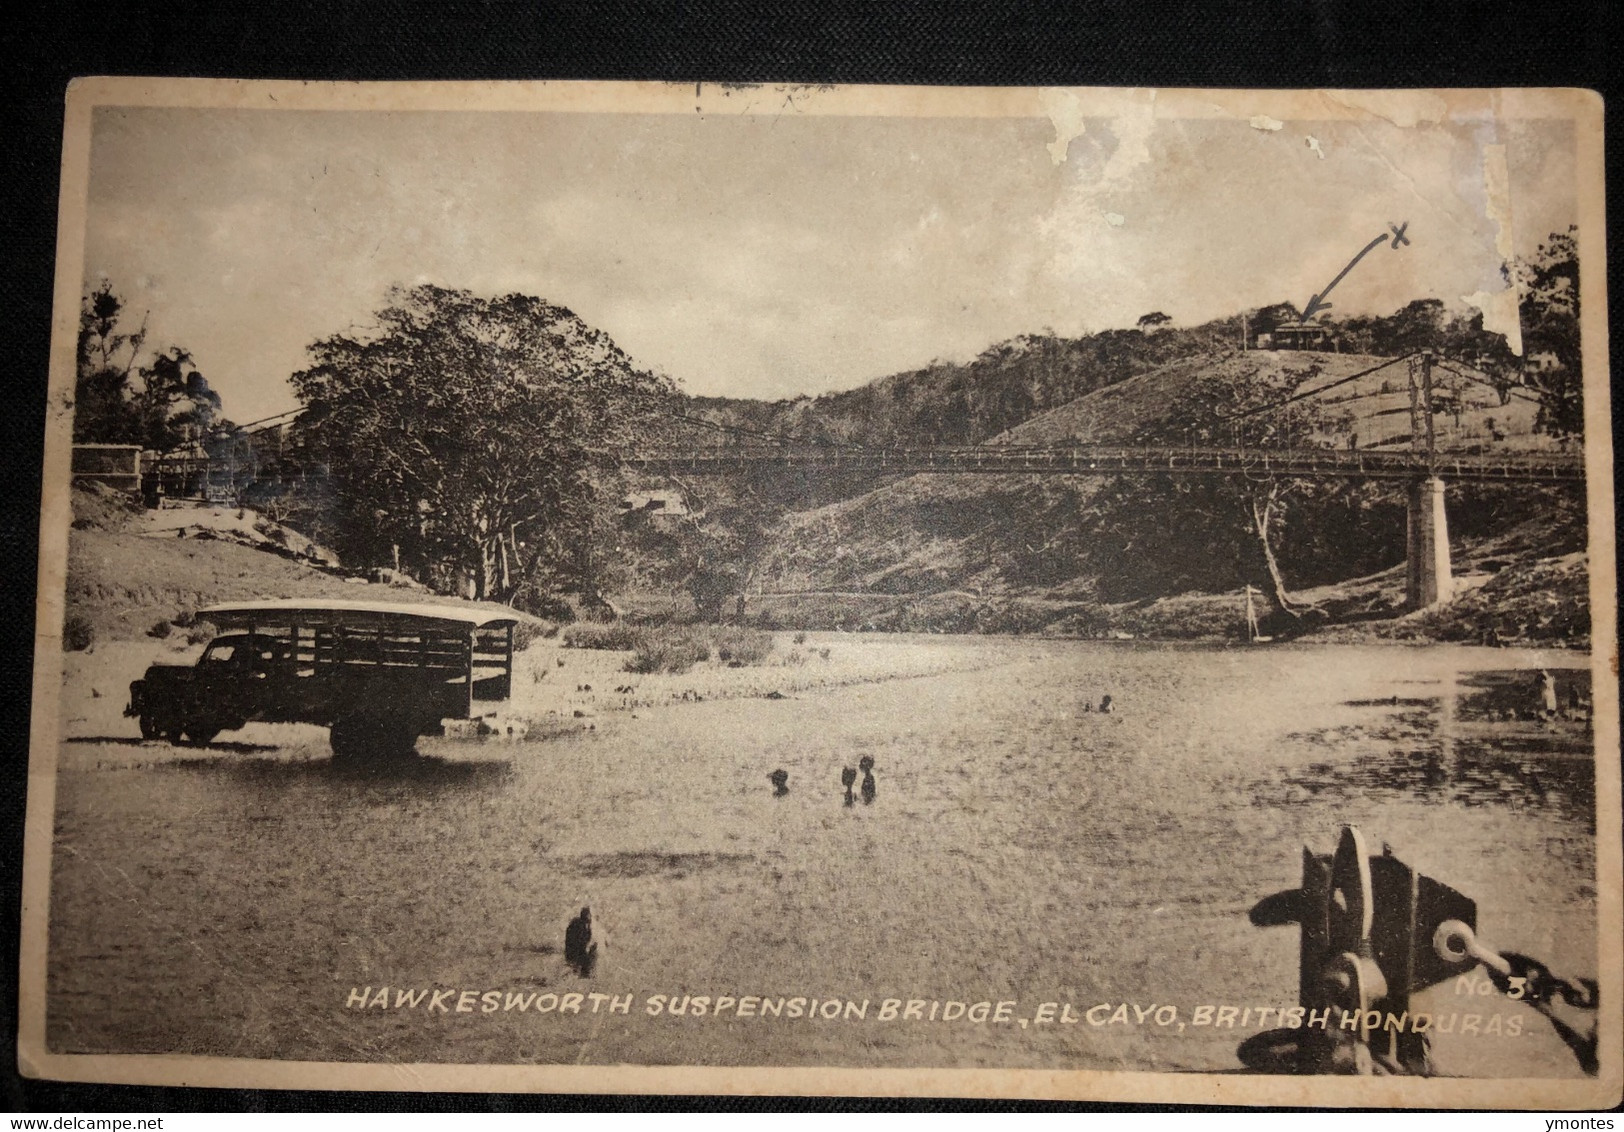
[292,286,674,601]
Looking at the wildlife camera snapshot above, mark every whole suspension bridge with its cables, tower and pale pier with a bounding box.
[88,351,1585,609]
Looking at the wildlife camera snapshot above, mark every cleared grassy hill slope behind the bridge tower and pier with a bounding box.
[714,351,1588,642]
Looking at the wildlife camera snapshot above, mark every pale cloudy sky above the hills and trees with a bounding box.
[84,99,1577,422]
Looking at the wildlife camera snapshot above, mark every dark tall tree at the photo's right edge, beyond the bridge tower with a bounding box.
[1507,227,1585,437]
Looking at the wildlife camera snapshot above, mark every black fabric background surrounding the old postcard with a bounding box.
[0,0,1624,1113]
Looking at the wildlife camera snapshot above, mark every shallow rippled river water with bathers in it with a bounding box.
[50,635,1596,1075]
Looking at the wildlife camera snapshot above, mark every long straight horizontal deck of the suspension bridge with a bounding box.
[622,445,1585,482]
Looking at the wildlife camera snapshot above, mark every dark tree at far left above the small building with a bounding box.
[73,283,221,452]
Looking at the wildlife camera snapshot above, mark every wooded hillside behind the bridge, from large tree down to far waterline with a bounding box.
[630,304,1588,643]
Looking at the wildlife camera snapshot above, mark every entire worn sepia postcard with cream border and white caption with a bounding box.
[18,78,1624,1109]
